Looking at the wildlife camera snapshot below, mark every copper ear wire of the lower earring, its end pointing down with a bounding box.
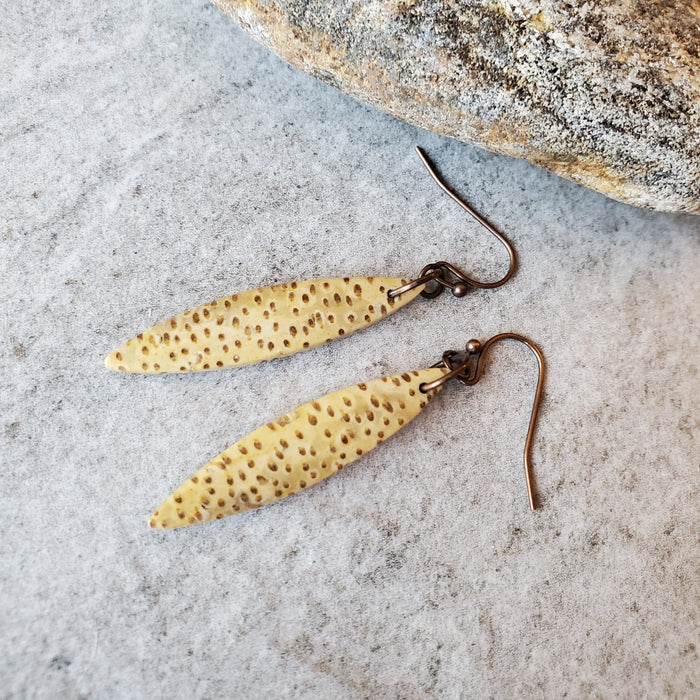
[420,333,544,510]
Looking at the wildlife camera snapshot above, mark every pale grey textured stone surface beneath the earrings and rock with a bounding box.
[0,0,700,698]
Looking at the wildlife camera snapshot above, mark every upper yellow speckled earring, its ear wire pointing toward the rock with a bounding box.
[105,147,516,374]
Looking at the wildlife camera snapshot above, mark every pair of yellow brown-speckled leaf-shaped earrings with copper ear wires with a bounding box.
[105,147,544,529]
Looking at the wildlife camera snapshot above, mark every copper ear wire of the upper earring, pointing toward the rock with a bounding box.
[388,146,517,299]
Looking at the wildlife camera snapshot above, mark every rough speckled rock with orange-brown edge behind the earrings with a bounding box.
[214,0,700,213]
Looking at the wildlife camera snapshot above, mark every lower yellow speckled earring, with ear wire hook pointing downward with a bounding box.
[149,333,544,529]
